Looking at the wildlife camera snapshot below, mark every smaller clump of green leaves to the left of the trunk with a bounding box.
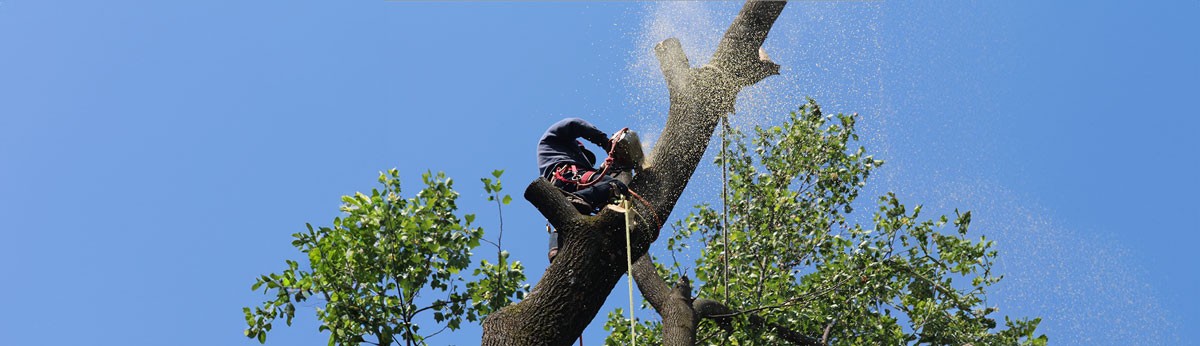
[242,169,528,345]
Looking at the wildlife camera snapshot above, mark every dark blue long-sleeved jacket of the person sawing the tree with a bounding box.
[538,118,608,177]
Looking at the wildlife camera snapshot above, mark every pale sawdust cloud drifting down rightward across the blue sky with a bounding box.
[624,1,1176,345]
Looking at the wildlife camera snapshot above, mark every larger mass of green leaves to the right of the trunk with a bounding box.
[606,100,1046,345]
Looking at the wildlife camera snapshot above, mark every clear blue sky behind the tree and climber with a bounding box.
[0,0,1200,345]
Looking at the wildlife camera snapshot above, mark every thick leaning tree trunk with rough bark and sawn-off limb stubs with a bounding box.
[482,1,785,346]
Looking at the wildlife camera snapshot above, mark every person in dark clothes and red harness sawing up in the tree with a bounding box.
[538,118,641,261]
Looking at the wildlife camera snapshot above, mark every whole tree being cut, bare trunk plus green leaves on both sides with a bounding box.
[244,1,1045,346]
